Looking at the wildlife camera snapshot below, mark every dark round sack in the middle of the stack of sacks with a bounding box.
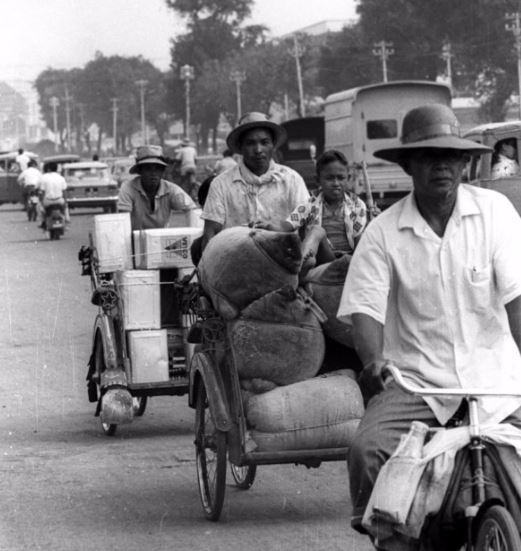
[228,287,325,392]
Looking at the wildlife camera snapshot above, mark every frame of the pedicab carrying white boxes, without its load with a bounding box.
[85,236,197,436]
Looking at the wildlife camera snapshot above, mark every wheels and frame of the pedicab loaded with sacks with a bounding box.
[185,288,348,521]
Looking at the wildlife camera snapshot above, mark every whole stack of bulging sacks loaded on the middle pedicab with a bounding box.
[199,227,363,451]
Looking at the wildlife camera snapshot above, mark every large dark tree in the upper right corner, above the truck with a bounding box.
[357,0,516,120]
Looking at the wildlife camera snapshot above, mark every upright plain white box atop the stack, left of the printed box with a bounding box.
[93,212,133,273]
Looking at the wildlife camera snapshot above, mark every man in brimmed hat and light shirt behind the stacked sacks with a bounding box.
[201,112,309,247]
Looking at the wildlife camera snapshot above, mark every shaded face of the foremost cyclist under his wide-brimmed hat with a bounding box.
[406,148,468,203]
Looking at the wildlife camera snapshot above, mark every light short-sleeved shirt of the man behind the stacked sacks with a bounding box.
[201,162,309,229]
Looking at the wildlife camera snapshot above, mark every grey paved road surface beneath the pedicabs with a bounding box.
[0,205,372,551]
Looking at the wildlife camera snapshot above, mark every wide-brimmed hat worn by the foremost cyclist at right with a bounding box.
[374,104,492,163]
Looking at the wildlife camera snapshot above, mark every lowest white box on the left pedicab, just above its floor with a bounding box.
[127,329,169,383]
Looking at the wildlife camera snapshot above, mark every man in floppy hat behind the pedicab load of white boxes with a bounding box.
[118,145,196,230]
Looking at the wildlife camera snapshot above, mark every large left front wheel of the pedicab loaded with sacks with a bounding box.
[195,381,226,521]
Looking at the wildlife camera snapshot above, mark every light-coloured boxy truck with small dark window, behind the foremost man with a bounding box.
[324,80,451,209]
